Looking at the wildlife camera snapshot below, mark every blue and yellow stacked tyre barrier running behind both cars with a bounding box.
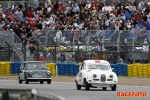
[0,62,150,76]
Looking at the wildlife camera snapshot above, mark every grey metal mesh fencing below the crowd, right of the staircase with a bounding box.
[33,30,150,62]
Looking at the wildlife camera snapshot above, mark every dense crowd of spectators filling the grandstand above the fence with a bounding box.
[0,0,150,39]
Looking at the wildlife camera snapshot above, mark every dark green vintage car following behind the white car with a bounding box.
[18,61,51,84]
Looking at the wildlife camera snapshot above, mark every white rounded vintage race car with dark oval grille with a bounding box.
[75,60,118,91]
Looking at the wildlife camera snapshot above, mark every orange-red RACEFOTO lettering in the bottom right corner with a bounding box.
[117,92,147,98]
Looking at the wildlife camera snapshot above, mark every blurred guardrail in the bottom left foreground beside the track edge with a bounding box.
[0,88,63,100]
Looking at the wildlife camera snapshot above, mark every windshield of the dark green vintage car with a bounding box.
[27,63,47,69]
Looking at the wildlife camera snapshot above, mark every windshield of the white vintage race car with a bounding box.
[88,64,110,70]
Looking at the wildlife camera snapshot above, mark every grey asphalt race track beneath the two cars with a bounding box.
[0,80,150,100]
